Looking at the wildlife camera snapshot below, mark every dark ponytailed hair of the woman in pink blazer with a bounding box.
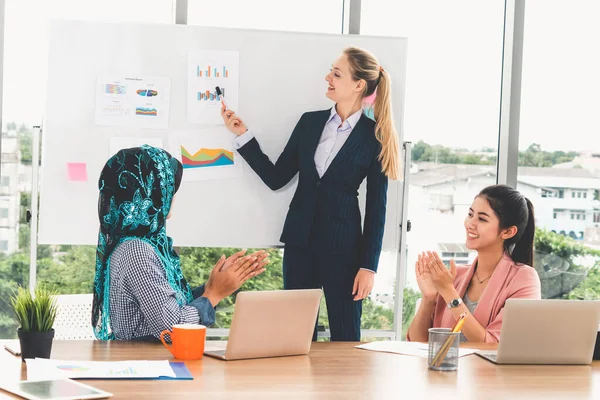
[478,185,535,267]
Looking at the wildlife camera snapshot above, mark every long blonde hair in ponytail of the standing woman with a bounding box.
[344,47,401,180]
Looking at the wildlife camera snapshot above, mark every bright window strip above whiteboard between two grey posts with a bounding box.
[188,0,343,33]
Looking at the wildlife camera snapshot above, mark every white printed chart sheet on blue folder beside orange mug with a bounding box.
[25,358,176,381]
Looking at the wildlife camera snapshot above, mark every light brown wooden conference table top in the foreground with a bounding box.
[0,341,600,400]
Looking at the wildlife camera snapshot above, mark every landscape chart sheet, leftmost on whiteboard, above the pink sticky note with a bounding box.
[95,76,171,129]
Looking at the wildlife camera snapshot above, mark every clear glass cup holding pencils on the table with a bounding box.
[428,328,460,371]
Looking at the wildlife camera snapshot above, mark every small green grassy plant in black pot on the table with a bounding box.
[10,287,57,361]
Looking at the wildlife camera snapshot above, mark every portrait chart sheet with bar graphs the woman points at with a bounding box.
[187,50,240,125]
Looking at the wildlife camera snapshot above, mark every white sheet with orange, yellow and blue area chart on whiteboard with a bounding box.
[169,127,243,181]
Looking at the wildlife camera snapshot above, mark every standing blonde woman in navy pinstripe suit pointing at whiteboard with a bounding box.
[221,47,400,341]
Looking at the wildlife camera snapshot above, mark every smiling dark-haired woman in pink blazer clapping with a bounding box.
[407,185,541,343]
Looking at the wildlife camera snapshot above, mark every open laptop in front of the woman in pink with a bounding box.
[476,299,600,364]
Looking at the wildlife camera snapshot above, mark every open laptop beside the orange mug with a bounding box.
[204,289,321,360]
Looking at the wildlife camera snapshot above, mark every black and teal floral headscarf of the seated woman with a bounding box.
[92,145,192,340]
